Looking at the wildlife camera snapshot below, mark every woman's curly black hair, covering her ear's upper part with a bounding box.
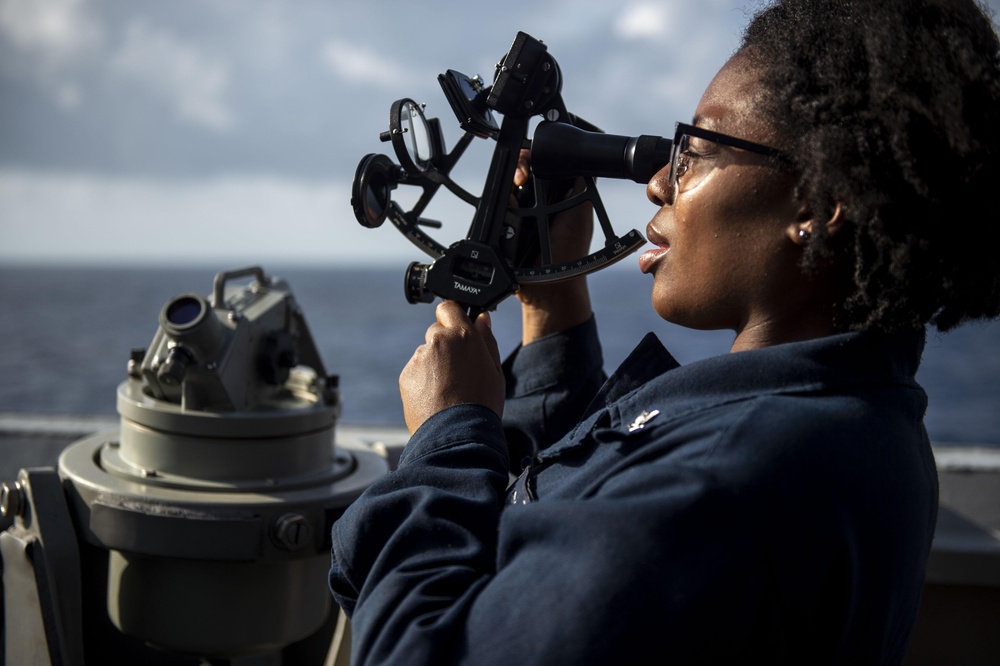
[742,0,1000,331]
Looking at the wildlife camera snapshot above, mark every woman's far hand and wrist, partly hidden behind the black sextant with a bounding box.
[514,150,594,345]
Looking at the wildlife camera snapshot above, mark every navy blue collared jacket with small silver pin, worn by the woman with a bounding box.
[330,322,937,665]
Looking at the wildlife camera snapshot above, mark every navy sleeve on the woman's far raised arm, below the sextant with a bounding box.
[503,317,607,466]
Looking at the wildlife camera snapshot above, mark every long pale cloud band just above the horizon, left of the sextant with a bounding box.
[0,170,421,266]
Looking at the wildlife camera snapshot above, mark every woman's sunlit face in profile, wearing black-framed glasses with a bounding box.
[639,53,802,348]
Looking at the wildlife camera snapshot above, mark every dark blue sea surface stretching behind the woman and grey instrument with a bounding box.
[0,265,1000,447]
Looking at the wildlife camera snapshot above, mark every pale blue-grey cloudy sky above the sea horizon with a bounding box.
[0,0,1000,266]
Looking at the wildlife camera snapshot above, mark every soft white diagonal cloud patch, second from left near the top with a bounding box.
[109,20,236,132]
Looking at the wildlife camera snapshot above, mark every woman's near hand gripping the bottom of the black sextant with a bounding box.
[399,301,506,434]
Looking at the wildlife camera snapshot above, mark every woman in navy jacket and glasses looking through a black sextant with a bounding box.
[330,0,1000,664]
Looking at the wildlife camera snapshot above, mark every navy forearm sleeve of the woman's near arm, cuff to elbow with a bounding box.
[330,405,508,664]
